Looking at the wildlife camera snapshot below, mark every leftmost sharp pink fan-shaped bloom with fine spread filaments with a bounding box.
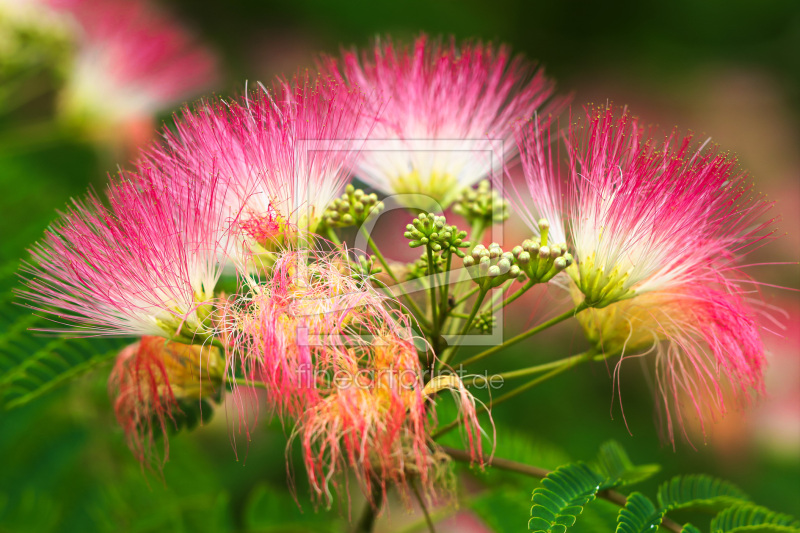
[21,164,235,342]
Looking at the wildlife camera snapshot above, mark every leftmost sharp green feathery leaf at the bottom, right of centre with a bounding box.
[528,463,603,533]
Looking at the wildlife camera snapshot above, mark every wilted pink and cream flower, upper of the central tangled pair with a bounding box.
[220,250,396,417]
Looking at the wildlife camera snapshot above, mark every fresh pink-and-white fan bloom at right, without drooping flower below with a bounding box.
[512,107,774,307]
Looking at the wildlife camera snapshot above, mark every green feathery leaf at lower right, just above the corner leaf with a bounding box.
[658,474,750,510]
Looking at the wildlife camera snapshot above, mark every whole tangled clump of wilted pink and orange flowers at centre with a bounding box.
[219,250,481,504]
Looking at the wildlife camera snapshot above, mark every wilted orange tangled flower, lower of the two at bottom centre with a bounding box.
[294,331,441,505]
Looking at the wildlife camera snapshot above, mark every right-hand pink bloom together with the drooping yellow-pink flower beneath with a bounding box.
[510,108,773,438]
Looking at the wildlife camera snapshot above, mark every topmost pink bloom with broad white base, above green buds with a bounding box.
[322,35,559,207]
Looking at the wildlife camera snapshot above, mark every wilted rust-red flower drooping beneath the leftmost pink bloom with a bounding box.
[108,336,225,463]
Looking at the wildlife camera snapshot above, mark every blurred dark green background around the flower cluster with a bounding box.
[0,0,800,532]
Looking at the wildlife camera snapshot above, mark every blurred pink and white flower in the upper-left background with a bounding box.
[54,0,217,143]
